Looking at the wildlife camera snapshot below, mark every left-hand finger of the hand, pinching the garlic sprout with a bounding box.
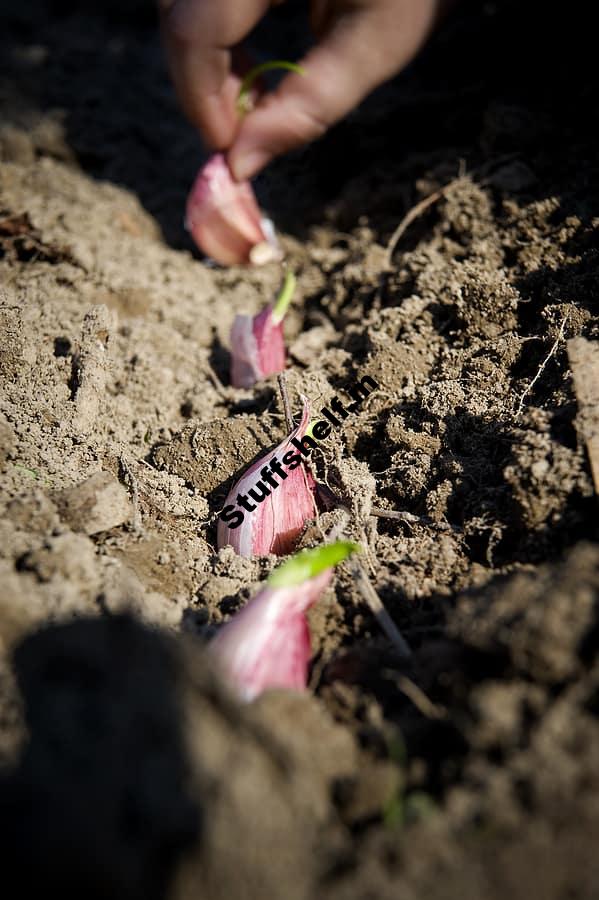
[159,0,269,149]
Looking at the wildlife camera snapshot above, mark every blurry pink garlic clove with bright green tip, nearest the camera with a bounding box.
[209,541,360,700]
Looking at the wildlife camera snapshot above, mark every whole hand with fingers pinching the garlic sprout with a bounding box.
[159,0,451,181]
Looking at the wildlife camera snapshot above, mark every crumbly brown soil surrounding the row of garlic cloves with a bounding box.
[0,0,599,900]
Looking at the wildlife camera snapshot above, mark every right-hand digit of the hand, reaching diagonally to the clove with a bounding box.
[228,0,438,180]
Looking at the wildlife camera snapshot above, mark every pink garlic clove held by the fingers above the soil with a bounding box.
[185,153,281,266]
